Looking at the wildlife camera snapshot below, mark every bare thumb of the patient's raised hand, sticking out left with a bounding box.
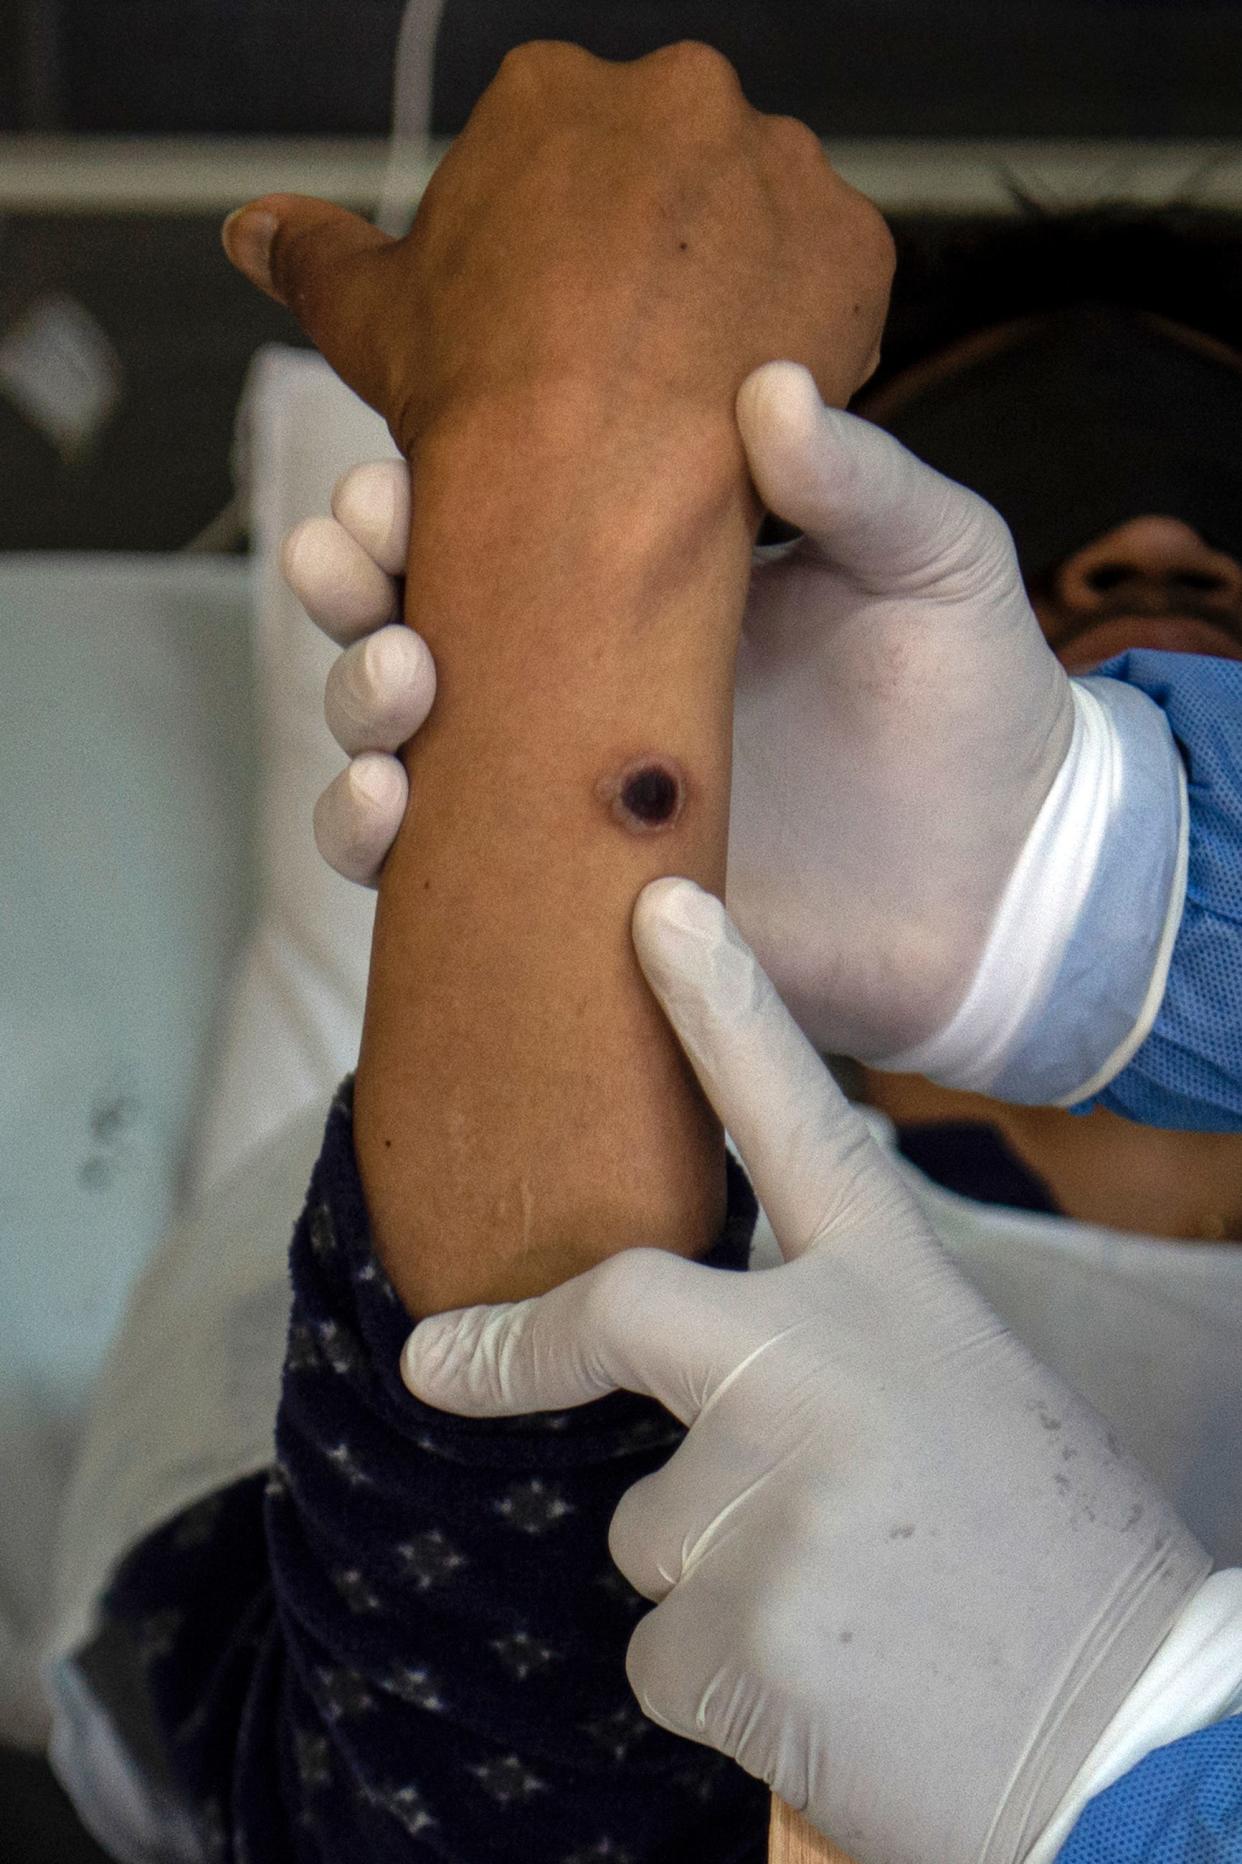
[220,194,397,412]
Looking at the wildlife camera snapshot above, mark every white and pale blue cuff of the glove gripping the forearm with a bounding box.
[873,678,1190,1105]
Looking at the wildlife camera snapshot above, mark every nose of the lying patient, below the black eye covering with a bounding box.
[1052,516,1242,615]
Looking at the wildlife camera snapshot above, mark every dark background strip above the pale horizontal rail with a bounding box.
[0,0,1242,136]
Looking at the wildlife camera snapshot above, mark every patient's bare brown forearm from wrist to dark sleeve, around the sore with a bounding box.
[354,393,755,1312]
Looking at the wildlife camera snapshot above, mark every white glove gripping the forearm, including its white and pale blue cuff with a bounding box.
[279,363,1184,1102]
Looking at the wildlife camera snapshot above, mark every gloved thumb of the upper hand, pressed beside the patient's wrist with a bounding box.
[737,362,1016,595]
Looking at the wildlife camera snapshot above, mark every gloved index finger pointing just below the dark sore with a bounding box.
[634,878,904,1260]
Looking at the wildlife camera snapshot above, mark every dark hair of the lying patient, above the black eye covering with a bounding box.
[869,190,1242,390]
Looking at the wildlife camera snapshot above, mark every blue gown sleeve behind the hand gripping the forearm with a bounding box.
[1074,649,1242,1131]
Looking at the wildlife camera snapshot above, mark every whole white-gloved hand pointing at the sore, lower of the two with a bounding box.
[403,880,1208,1864]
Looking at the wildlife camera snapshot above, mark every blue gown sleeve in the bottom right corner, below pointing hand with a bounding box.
[1057,1715,1242,1864]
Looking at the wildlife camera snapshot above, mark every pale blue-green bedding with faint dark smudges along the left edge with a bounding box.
[0,555,254,1739]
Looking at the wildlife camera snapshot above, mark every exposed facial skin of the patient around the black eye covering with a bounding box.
[858,319,1242,673]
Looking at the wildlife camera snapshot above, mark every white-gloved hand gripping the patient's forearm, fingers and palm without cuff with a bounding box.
[285,376,1074,1059]
